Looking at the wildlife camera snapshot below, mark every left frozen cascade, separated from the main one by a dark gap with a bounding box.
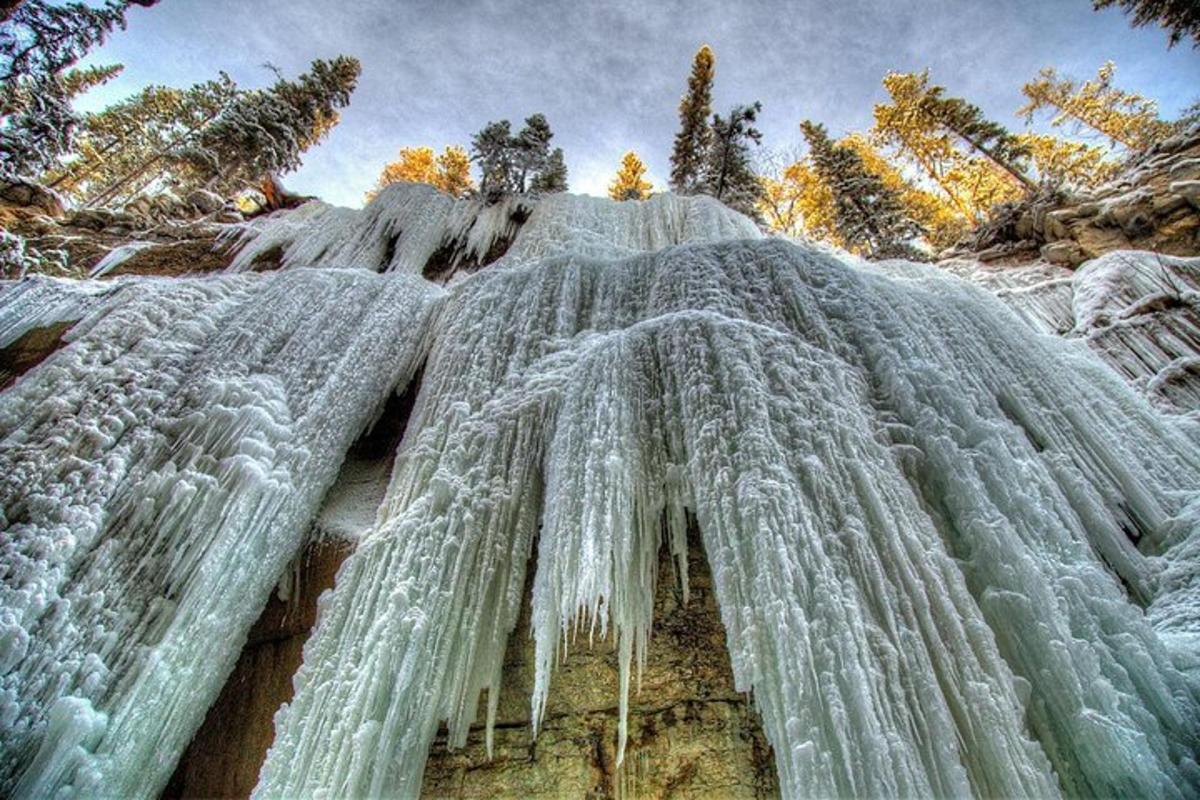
[0,270,440,796]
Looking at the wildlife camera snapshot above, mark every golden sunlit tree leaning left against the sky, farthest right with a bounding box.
[1016,61,1174,150]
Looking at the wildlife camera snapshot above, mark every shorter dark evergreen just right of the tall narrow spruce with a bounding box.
[700,102,762,217]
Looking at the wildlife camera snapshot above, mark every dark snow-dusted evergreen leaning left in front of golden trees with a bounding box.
[800,120,924,258]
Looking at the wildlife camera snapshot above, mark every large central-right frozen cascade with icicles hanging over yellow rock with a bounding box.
[250,198,1200,798]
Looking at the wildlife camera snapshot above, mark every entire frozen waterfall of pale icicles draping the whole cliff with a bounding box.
[0,187,1200,798]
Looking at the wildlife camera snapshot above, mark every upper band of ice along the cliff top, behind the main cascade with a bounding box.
[229,184,762,275]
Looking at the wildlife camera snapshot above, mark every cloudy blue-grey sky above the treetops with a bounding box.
[77,0,1200,205]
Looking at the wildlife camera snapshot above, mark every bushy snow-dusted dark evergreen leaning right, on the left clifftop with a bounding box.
[178,55,361,194]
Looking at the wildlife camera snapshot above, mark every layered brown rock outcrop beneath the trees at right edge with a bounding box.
[944,126,1200,267]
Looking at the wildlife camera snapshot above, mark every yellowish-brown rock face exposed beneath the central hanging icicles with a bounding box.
[421,531,779,800]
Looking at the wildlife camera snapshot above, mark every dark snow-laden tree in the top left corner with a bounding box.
[0,0,156,174]
